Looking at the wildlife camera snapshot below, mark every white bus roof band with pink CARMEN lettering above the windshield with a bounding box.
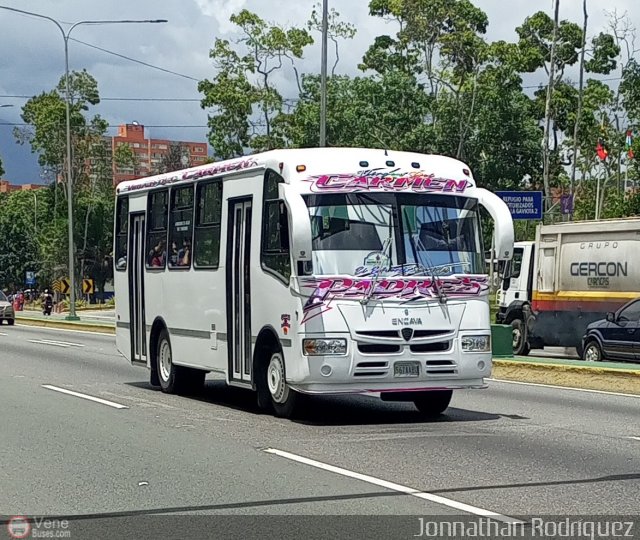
[117,148,476,195]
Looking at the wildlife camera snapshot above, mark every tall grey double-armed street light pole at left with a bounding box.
[0,6,168,321]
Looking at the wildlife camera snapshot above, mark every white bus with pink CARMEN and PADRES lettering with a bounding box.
[114,148,513,416]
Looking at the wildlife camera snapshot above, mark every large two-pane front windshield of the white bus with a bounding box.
[305,192,485,277]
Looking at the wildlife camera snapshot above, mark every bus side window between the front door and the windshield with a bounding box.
[260,170,291,282]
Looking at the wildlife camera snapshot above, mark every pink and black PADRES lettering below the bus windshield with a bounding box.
[300,276,489,324]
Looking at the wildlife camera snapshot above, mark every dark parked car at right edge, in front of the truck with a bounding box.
[582,298,640,362]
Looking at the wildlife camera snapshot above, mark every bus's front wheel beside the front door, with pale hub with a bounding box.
[257,351,303,418]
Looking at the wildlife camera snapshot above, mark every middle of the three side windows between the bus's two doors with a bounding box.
[167,186,193,268]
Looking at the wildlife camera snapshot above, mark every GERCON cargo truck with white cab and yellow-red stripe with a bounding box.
[496,218,640,357]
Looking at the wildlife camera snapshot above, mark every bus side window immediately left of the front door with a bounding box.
[193,180,222,269]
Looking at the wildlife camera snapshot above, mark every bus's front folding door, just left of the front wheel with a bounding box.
[227,198,253,384]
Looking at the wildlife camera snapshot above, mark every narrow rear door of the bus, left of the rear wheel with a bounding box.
[129,213,147,365]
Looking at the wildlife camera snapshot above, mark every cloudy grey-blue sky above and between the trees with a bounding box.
[0,0,640,183]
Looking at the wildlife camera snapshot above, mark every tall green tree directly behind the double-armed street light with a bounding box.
[14,70,114,298]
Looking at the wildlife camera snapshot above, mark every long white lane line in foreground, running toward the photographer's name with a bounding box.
[264,448,524,523]
